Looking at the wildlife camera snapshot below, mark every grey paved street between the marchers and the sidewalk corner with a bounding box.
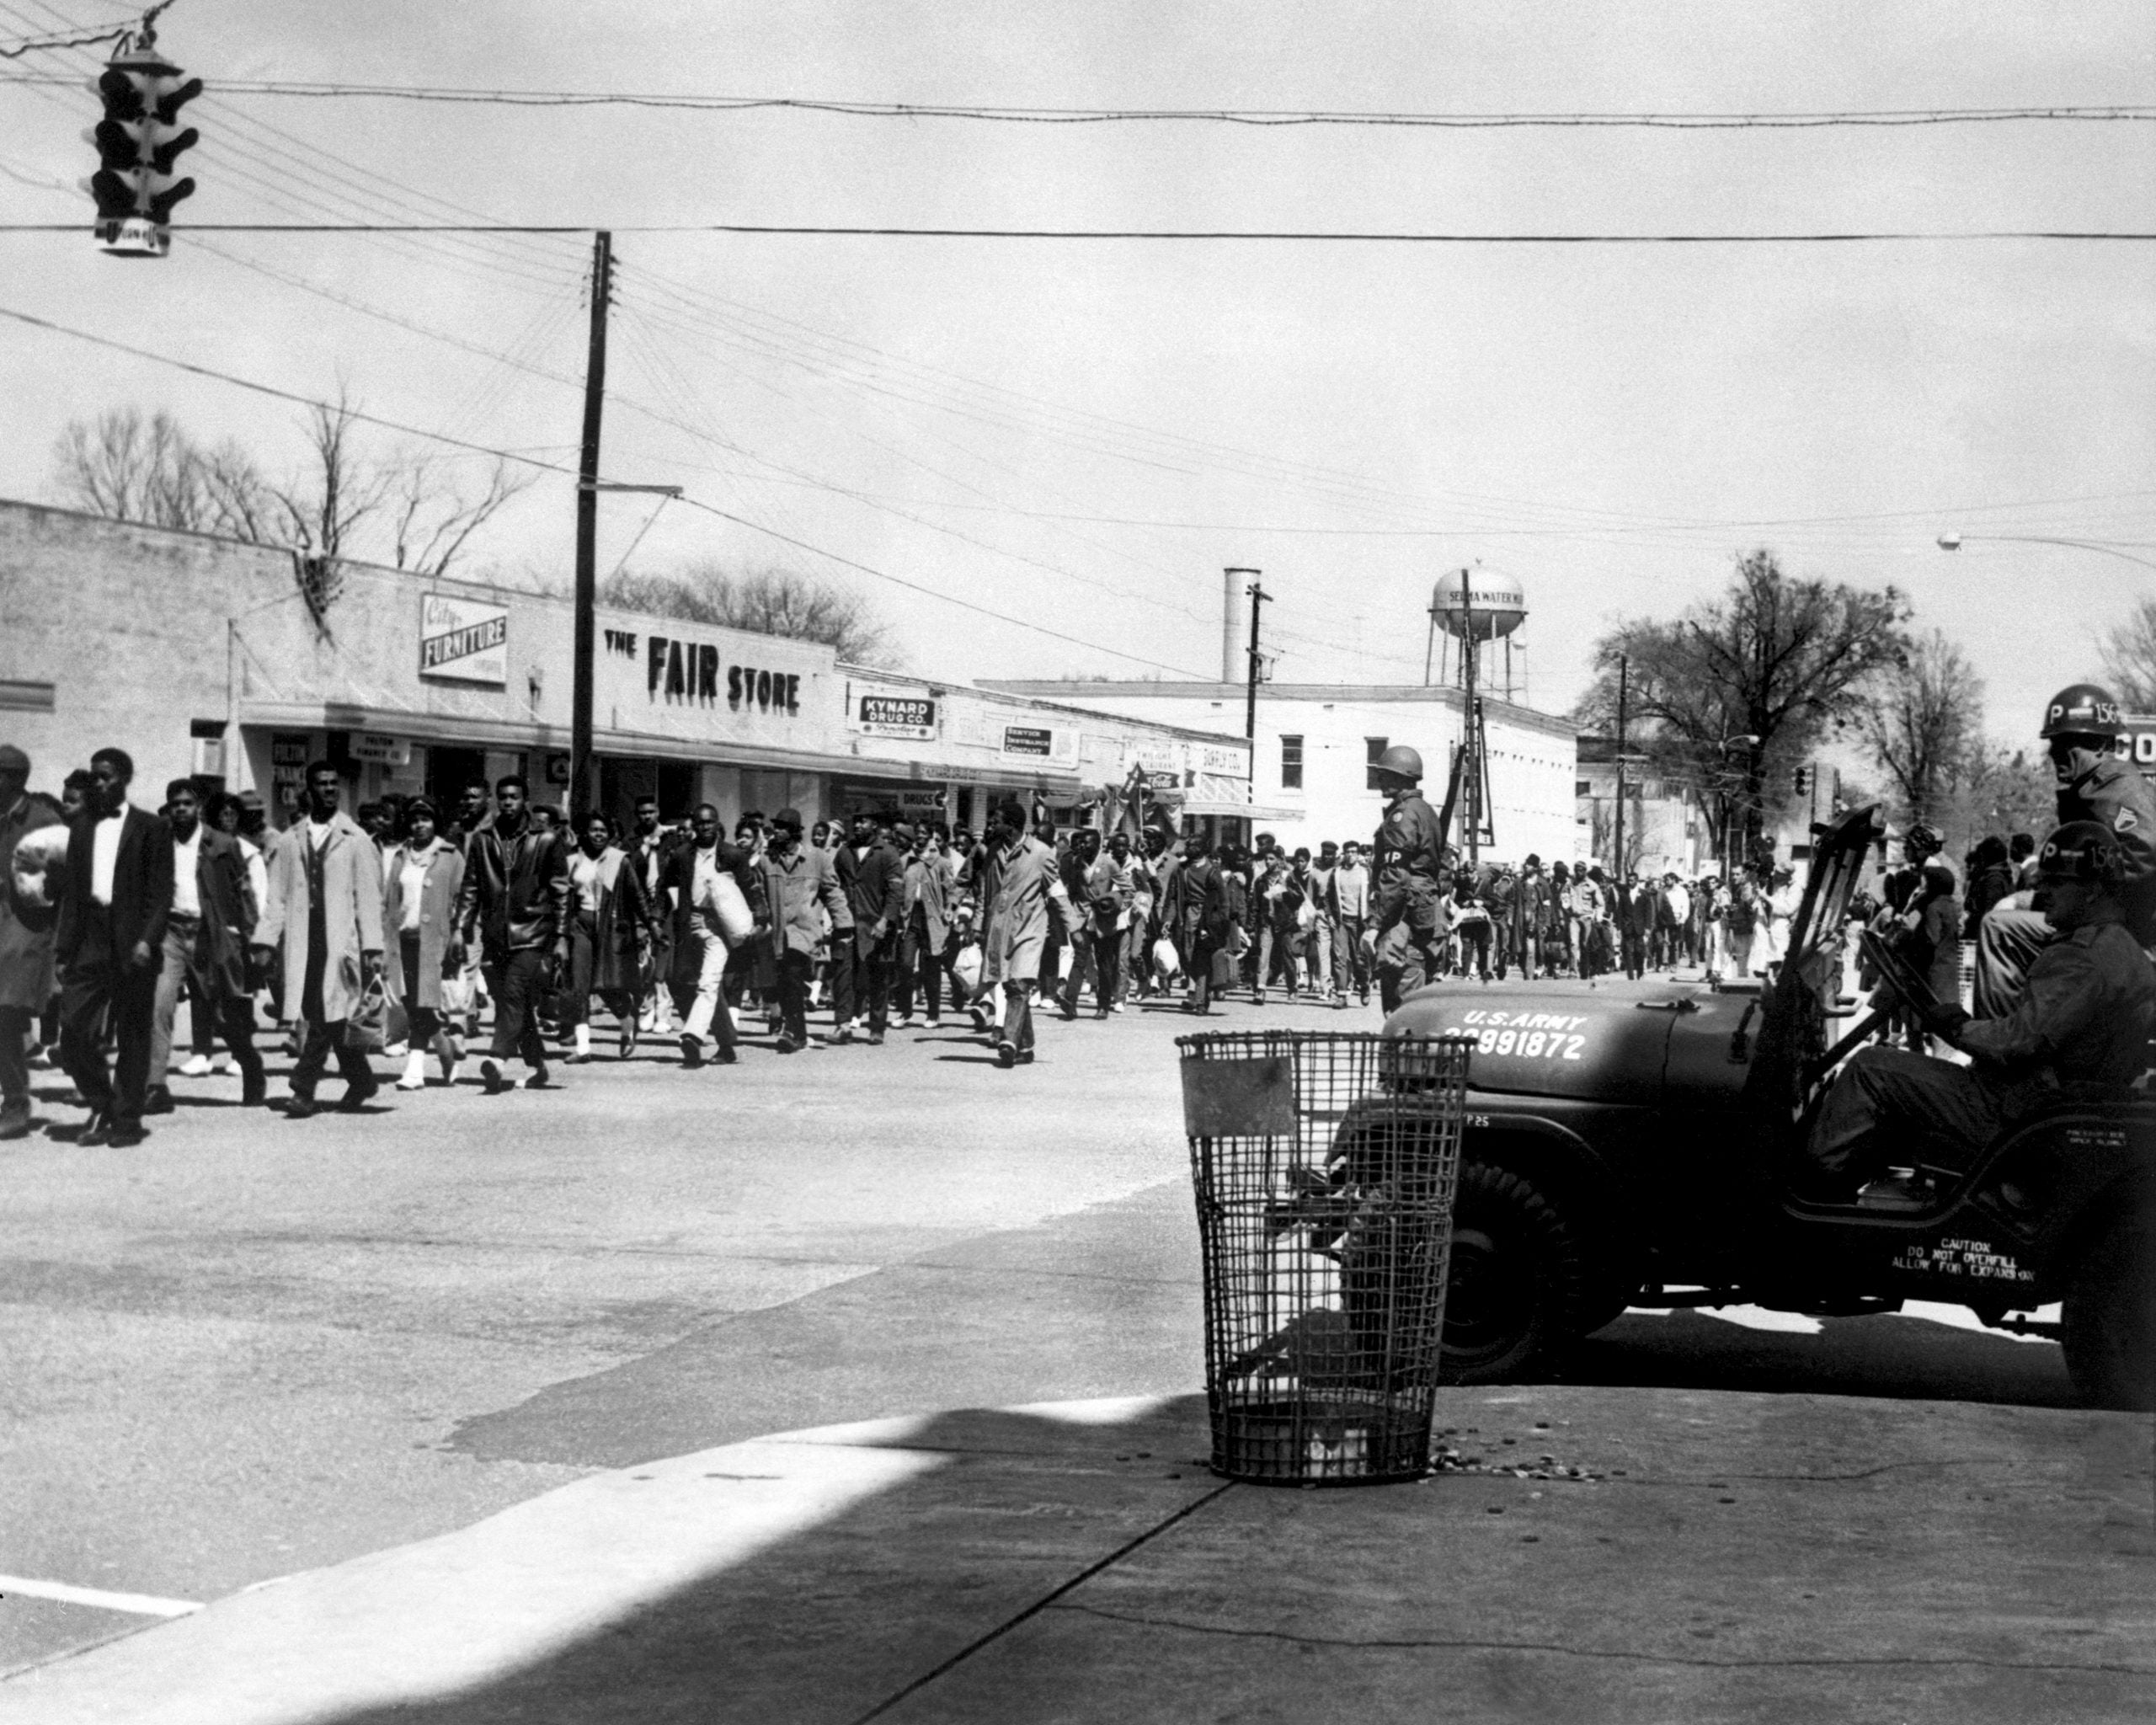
[0,991,2145,1716]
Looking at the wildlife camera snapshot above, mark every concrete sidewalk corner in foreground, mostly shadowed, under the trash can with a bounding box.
[0,1386,2156,1725]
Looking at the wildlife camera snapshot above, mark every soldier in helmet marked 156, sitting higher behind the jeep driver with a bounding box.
[1977,684,2156,1017]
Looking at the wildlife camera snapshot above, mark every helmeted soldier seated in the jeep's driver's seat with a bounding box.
[1801,821,2156,1201]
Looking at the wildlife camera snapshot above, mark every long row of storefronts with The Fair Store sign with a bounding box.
[0,498,1248,828]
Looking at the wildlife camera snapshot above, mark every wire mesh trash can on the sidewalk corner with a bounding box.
[1175,1031,1475,1486]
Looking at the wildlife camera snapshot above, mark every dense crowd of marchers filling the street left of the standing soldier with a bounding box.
[0,733,1465,1145]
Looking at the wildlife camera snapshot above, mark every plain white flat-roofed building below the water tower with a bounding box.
[981,679,1578,860]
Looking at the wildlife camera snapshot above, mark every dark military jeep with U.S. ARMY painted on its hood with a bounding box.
[1339,809,2156,1408]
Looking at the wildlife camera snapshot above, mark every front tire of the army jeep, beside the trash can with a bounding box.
[1440,1162,1587,1385]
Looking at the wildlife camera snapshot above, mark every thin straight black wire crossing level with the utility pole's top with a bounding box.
[0,222,2156,246]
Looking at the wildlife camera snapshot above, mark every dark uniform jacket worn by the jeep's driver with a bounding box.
[1960,923,2156,1087]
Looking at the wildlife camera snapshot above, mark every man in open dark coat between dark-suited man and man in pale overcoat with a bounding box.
[147,778,270,1115]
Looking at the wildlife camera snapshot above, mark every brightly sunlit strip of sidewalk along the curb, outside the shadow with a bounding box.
[0,1397,1181,1725]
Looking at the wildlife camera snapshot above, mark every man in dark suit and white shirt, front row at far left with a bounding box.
[54,748,173,1147]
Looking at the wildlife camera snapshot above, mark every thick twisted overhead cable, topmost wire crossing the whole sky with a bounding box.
[15,77,2156,131]
